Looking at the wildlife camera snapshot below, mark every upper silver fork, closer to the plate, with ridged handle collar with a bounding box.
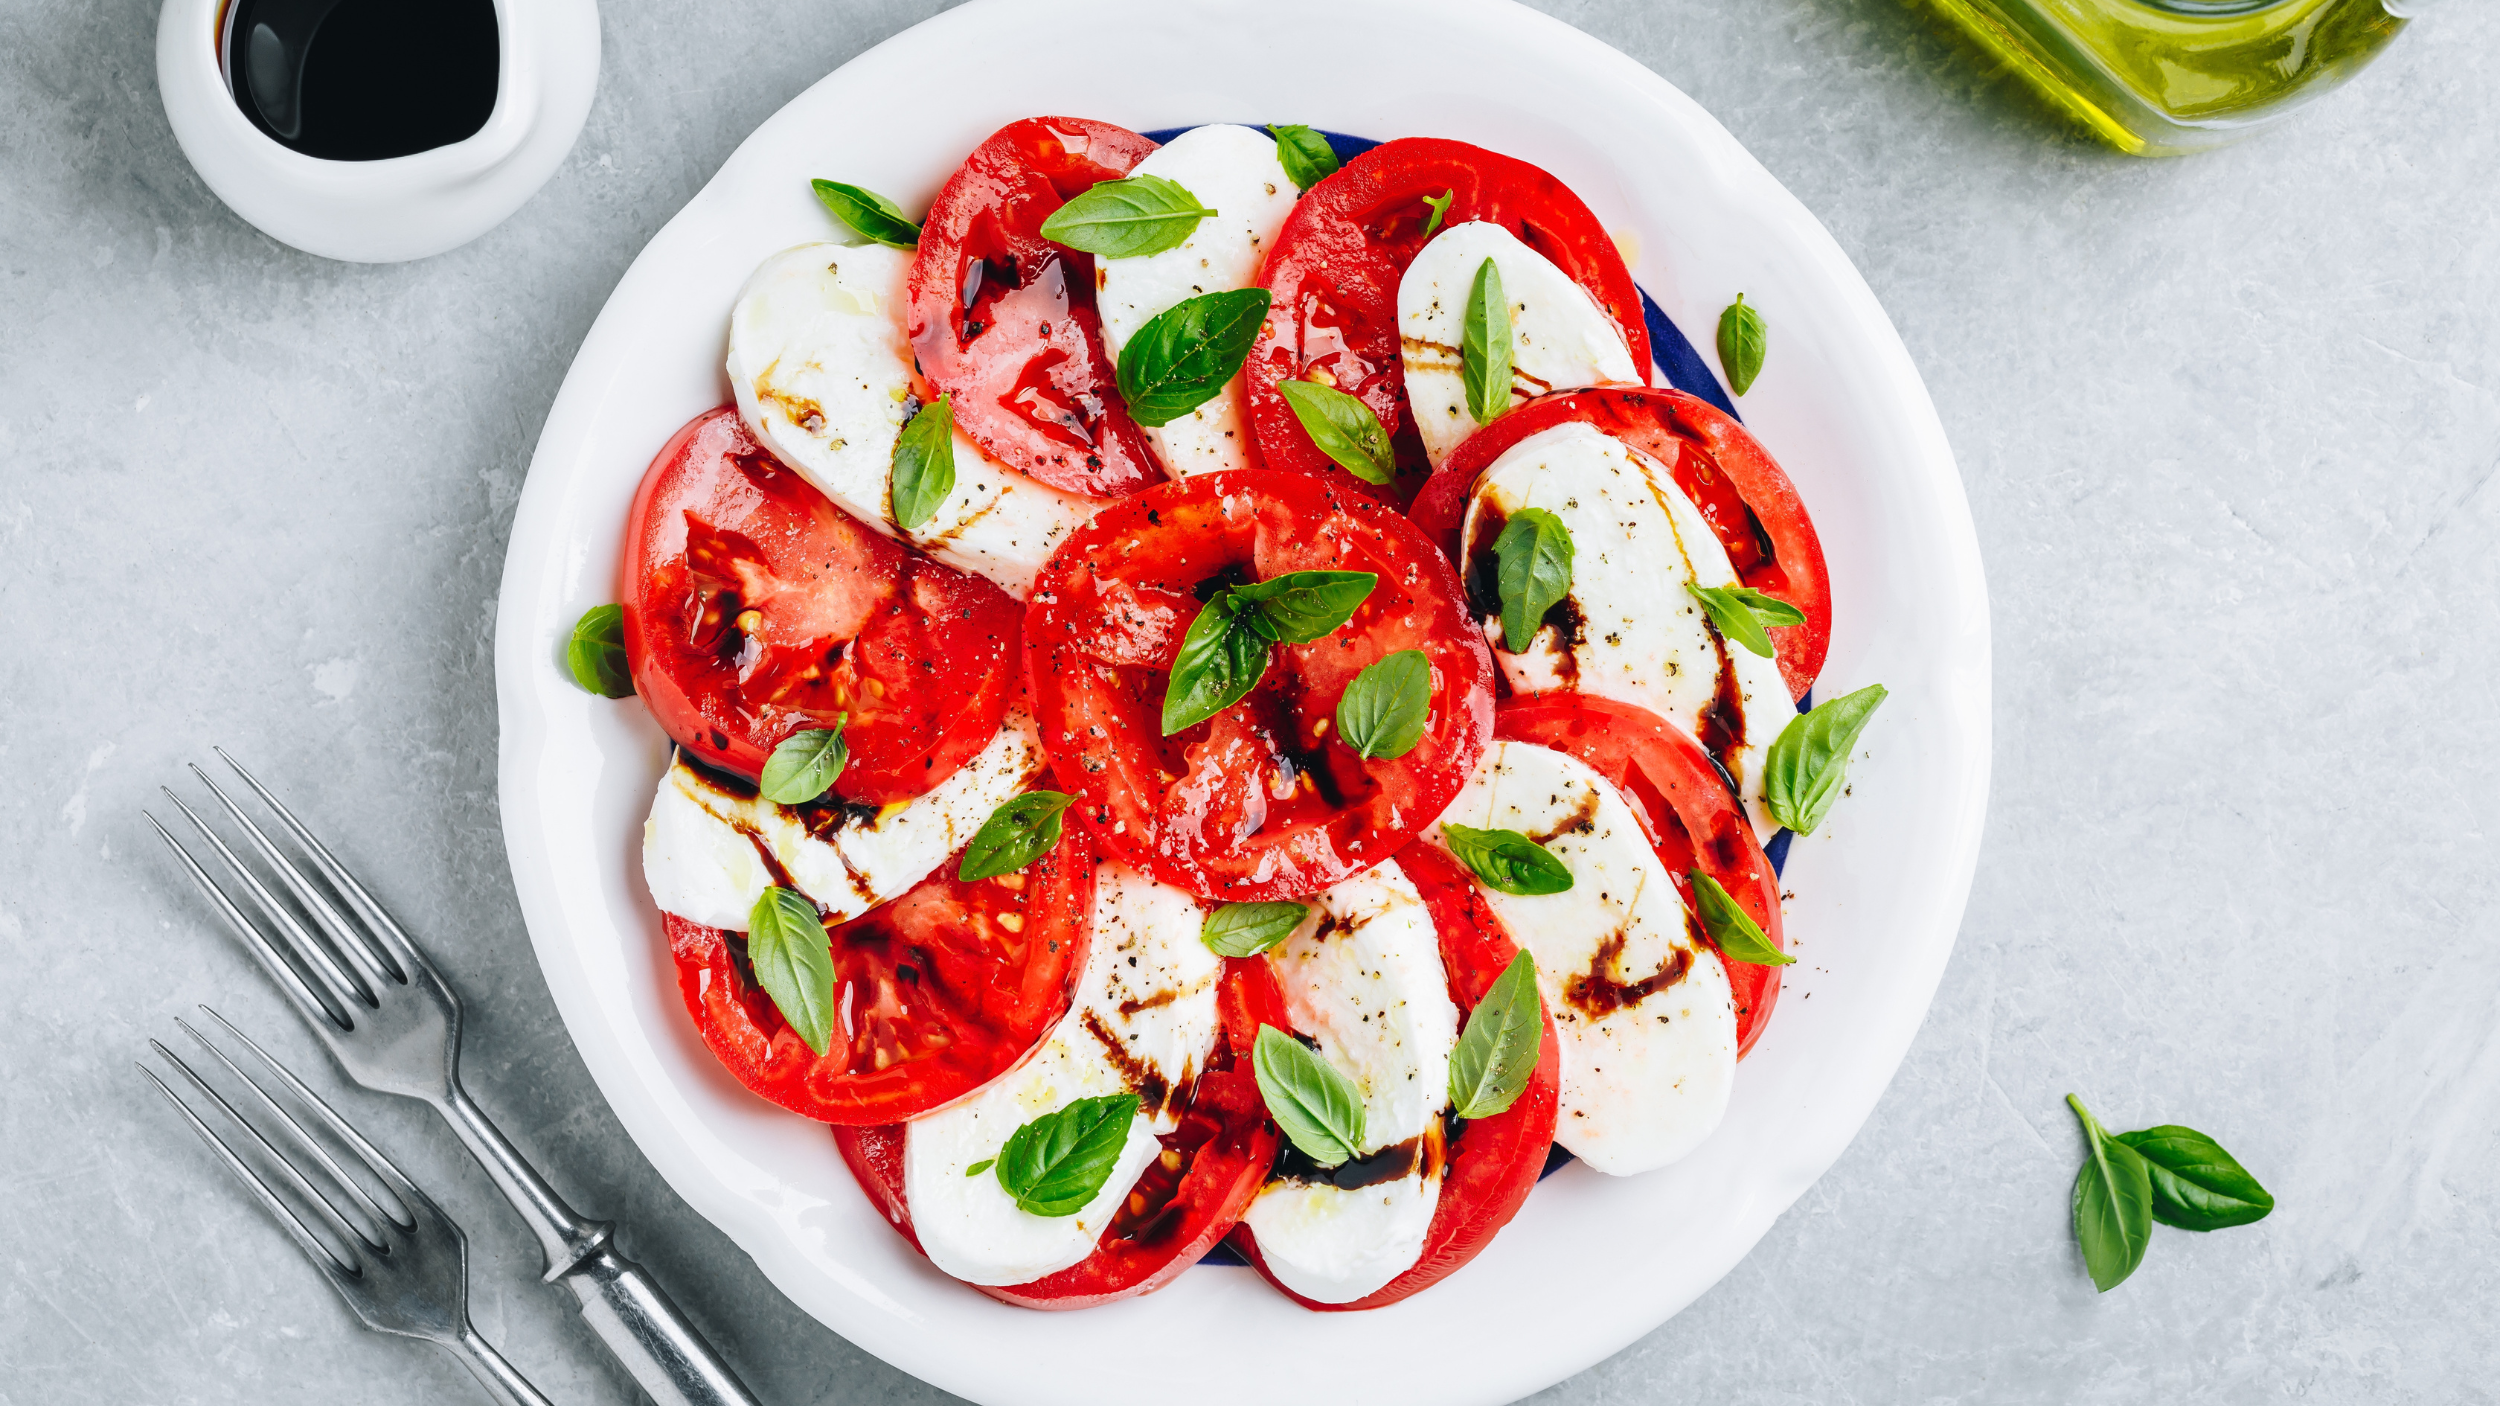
[148,748,755,1406]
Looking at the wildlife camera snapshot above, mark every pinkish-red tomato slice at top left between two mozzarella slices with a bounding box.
[908,118,1163,498]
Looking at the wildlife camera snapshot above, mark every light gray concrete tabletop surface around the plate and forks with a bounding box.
[0,0,2500,1406]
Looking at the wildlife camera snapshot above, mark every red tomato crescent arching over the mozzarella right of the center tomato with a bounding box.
[1410,385,1833,698]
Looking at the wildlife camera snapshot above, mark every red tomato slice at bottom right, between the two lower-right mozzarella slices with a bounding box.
[1233,846,1563,1313]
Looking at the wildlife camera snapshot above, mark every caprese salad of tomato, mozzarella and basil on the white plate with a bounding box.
[568,118,1883,1308]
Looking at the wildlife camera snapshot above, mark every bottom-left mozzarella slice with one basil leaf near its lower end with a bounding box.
[903,861,1223,1283]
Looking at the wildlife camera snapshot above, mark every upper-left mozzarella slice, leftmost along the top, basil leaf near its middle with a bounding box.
[730,243,1100,590]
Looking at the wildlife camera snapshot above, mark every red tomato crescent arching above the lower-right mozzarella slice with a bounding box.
[1490,693,1788,1058]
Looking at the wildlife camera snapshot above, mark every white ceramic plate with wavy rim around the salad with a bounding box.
[495,0,1988,1406]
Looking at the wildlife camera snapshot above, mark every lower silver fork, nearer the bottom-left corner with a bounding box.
[140,1006,548,1406]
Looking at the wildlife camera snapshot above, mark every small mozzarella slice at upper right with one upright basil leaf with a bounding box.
[1398,220,1648,468]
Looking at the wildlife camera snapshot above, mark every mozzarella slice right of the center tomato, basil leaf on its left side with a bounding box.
[1460,423,1798,838]
